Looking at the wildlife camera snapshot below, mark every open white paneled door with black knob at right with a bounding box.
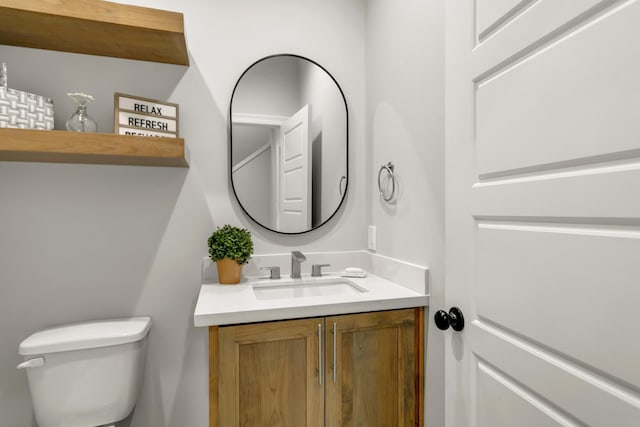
[448,0,640,427]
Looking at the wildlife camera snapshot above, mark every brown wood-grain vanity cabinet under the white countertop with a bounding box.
[209,308,424,427]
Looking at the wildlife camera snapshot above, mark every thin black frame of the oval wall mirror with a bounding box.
[227,53,349,235]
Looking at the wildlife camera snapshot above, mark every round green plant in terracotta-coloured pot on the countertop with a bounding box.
[209,224,253,284]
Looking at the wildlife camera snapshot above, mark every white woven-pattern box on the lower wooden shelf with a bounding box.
[0,62,53,130]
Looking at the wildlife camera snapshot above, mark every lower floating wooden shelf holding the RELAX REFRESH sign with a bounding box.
[0,129,189,167]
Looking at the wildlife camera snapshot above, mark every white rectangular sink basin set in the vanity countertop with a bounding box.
[253,279,367,300]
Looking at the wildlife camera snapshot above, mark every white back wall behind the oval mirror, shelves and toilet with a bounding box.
[0,0,366,427]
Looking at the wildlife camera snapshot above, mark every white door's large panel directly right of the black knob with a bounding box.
[476,222,640,388]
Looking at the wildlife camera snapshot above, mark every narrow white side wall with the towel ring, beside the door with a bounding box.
[366,0,444,427]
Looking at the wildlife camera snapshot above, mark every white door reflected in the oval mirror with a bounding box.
[277,105,311,233]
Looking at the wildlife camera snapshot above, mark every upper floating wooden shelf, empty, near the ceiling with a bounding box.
[0,0,189,65]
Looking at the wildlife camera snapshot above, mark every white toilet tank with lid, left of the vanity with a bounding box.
[18,317,151,427]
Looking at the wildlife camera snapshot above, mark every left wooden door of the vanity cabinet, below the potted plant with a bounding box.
[210,318,324,427]
